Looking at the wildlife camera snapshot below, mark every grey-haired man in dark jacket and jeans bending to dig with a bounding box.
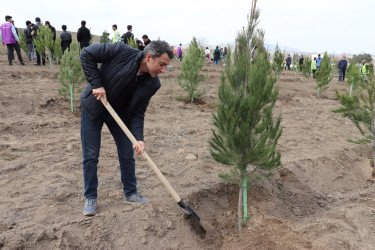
[80,41,174,216]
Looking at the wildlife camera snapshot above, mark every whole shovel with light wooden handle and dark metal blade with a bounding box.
[101,98,210,232]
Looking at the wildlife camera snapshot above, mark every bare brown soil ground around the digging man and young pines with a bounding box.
[0,48,375,249]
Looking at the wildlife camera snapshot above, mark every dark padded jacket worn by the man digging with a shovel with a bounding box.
[80,43,160,141]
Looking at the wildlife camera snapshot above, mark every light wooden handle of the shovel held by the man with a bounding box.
[101,98,181,203]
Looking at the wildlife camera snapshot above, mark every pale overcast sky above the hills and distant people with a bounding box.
[0,0,375,54]
